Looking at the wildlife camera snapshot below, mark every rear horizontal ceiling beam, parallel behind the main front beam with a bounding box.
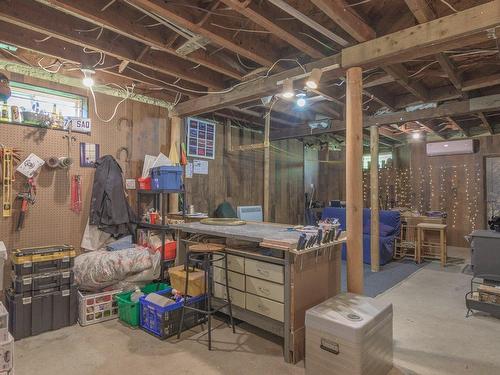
[272,94,500,139]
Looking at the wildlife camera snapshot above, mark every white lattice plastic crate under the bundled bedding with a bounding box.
[78,290,121,326]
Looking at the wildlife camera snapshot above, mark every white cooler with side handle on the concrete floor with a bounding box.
[305,293,392,375]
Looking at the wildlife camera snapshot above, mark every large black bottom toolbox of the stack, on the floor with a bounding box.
[5,286,78,340]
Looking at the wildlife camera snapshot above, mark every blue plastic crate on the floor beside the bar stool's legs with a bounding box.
[139,288,207,340]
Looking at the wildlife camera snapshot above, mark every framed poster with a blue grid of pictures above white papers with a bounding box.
[187,117,215,159]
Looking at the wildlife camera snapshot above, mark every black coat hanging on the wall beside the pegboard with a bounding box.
[90,155,138,237]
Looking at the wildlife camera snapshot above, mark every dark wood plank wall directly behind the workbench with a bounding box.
[186,123,304,224]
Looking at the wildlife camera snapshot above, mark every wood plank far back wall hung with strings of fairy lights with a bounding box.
[306,136,500,247]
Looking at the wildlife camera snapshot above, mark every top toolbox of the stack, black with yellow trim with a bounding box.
[11,245,76,276]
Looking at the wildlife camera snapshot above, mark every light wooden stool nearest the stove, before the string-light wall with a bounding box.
[415,223,448,267]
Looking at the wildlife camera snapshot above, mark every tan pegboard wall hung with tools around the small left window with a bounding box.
[0,72,169,256]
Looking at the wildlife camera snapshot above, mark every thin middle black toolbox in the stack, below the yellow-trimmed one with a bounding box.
[11,270,75,294]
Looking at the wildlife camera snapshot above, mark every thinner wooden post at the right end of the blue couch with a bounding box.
[370,125,380,272]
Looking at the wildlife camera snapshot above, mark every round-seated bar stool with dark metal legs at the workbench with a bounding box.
[177,243,236,350]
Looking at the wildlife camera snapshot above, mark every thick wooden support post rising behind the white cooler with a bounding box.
[346,67,363,294]
